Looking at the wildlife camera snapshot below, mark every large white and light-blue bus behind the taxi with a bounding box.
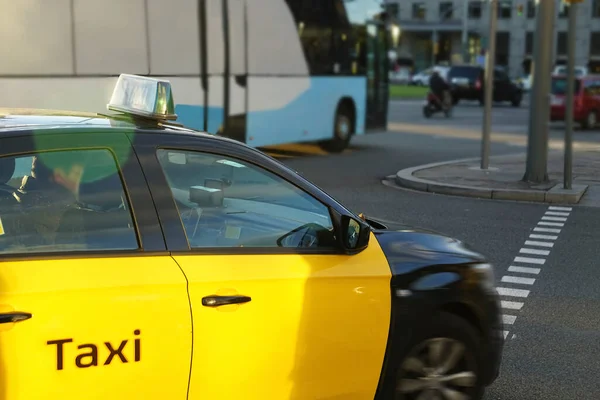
[0,0,389,151]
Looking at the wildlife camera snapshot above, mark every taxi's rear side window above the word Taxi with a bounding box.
[0,150,139,254]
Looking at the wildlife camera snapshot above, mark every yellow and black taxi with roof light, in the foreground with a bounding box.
[0,75,503,400]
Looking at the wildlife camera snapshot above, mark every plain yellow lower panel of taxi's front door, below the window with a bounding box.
[174,234,391,400]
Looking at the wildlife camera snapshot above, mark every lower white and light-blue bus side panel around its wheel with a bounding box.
[247,77,366,146]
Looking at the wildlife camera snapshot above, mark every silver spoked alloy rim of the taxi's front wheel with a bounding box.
[396,338,477,400]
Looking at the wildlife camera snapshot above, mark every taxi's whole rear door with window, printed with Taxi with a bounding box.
[0,132,192,400]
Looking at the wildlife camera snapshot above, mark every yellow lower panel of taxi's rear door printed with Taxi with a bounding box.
[0,256,191,400]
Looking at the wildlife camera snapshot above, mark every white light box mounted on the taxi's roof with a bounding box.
[107,74,177,120]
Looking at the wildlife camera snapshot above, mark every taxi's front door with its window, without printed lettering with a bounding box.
[137,135,391,400]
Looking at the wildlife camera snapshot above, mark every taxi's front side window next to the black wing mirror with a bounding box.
[157,149,337,249]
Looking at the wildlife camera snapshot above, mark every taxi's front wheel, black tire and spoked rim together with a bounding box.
[395,312,485,400]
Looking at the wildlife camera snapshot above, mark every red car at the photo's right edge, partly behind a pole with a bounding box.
[550,75,600,129]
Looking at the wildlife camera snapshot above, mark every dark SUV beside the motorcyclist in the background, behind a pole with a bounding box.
[447,65,523,107]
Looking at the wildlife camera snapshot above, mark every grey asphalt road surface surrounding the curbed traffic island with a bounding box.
[270,102,600,400]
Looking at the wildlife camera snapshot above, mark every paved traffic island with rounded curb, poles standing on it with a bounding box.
[395,152,600,204]
